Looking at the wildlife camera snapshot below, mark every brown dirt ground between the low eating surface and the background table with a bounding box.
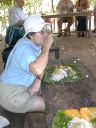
[49,33,96,77]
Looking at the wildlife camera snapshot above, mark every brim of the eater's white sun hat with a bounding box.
[23,22,51,38]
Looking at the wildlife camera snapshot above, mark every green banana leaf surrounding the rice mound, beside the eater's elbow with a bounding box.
[42,64,85,85]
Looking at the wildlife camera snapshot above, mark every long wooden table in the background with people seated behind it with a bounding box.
[41,11,93,37]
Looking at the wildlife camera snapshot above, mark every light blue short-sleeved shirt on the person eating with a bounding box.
[0,38,41,87]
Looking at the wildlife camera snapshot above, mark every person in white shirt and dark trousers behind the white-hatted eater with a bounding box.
[2,0,26,64]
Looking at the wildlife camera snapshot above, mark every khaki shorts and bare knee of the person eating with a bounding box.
[0,82,45,113]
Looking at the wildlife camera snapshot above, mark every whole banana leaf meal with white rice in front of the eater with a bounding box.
[43,64,84,84]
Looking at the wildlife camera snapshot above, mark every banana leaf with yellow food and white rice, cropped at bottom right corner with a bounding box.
[52,107,96,128]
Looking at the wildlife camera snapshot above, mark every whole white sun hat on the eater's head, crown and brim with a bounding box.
[23,15,50,37]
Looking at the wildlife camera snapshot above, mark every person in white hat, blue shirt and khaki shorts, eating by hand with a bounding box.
[0,15,53,113]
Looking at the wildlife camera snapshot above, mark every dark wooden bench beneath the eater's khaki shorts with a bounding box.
[0,106,48,128]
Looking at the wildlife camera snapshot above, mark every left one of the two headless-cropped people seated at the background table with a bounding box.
[56,0,74,37]
